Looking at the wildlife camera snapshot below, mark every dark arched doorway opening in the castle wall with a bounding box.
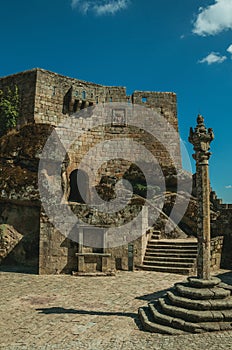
[68,169,89,203]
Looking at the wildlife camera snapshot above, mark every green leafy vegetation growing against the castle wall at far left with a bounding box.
[0,86,20,137]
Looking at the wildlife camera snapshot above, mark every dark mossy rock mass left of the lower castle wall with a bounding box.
[0,124,52,265]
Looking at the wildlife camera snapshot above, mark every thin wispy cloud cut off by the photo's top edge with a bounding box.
[71,0,130,16]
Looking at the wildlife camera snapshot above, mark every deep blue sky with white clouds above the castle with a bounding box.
[0,0,232,203]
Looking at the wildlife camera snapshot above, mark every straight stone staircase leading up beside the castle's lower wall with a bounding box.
[141,231,197,275]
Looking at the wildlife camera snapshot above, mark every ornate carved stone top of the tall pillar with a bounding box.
[188,114,214,164]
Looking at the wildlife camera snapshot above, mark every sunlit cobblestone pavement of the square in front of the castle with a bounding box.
[0,271,232,350]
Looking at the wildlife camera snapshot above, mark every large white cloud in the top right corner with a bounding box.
[193,0,232,36]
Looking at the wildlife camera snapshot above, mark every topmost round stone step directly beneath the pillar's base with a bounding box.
[175,283,231,300]
